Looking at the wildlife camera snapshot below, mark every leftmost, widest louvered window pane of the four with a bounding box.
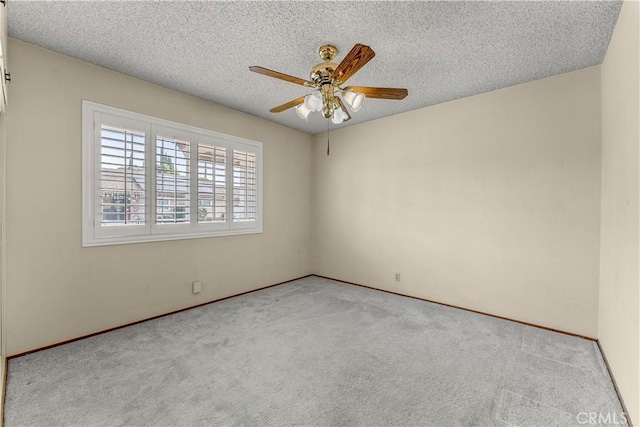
[100,125,145,226]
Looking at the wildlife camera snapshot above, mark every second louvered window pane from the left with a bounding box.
[156,136,191,224]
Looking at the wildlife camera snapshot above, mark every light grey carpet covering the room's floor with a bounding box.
[5,277,621,427]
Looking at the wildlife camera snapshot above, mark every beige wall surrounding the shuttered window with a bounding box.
[6,39,312,355]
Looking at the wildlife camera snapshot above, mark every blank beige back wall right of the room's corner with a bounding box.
[313,67,600,337]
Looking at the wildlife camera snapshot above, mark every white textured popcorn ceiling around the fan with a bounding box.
[8,0,622,134]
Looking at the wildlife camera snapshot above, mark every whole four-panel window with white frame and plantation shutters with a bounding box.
[82,101,262,246]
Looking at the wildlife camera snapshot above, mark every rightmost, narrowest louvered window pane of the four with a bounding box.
[233,150,257,222]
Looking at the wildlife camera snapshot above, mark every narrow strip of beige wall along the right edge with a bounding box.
[598,2,640,425]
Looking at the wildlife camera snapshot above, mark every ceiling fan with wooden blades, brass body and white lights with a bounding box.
[249,44,409,124]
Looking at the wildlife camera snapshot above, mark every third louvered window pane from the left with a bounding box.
[198,144,227,222]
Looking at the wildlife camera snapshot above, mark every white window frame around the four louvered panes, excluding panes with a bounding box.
[82,100,263,247]
